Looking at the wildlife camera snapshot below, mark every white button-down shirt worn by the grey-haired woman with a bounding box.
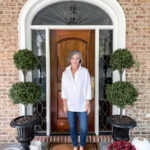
[61,65,92,112]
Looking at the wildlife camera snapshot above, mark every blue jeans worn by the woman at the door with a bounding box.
[67,111,88,147]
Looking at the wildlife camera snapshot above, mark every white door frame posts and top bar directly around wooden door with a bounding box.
[46,26,104,135]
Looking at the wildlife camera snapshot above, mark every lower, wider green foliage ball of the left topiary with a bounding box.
[9,82,41,105]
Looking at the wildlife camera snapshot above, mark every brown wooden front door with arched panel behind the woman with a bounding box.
[50,30,95,133]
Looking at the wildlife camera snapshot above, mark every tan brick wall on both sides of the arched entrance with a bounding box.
[0,0,150,143]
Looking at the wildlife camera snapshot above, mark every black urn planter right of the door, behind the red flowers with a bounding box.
[107,115,136,141]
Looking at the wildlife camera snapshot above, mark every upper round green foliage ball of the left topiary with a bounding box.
[13,49,38,71]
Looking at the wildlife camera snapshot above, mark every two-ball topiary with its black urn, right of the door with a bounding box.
[106,49,138,140]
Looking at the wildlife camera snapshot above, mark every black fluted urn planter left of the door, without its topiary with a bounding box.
[10,116,39,150]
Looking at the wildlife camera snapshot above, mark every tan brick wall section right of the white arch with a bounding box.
[118,0,150,140]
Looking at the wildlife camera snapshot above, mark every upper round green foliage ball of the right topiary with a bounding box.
[109,49,135,71]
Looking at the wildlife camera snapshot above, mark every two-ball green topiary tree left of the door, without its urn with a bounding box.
[9,49,41,117]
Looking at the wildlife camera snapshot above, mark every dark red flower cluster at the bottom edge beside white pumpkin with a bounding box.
[107,140,136,150]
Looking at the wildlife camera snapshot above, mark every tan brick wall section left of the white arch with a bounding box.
[0,0,25,143]
